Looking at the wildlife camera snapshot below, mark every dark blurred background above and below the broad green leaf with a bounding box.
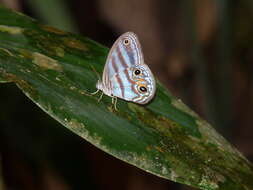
[0,0,253,190]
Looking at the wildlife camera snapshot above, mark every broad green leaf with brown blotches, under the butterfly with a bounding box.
[0,5,253,190]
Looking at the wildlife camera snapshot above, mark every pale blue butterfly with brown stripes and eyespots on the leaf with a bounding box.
[96,32,156,108]
